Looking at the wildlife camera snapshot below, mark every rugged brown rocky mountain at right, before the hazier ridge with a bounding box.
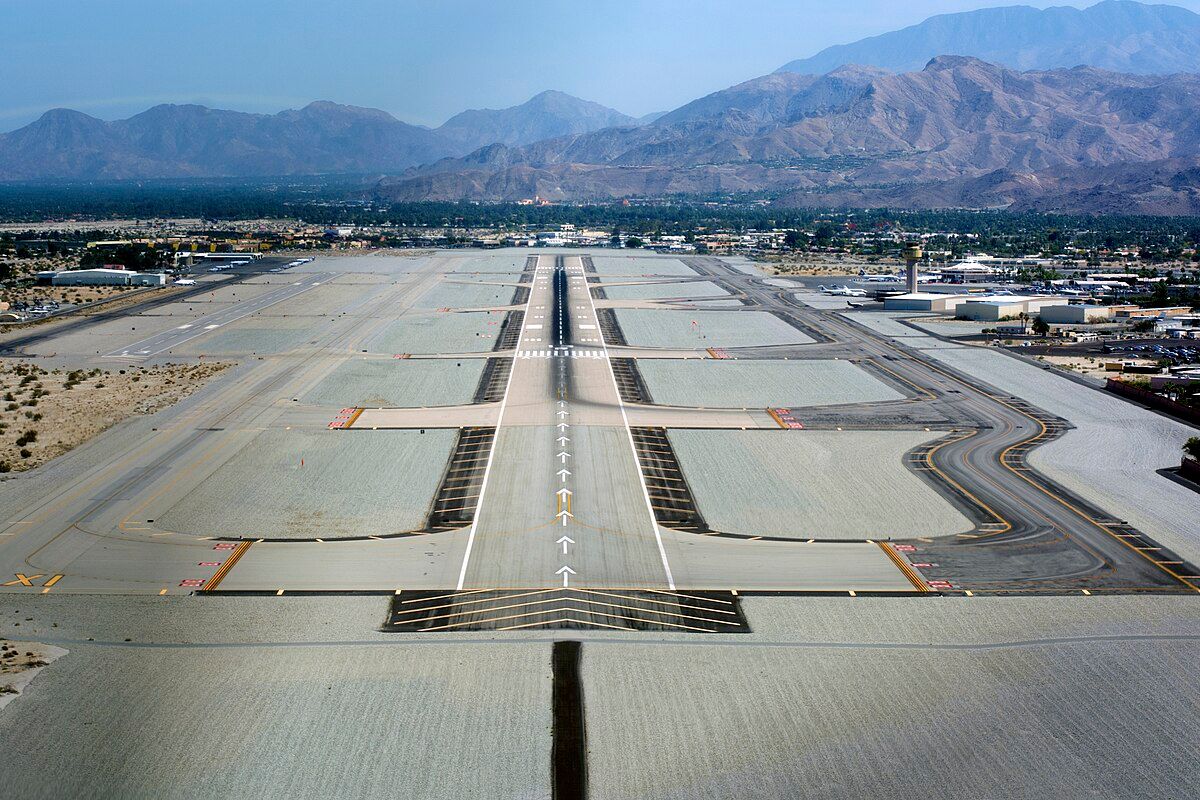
[376,56,1200,212]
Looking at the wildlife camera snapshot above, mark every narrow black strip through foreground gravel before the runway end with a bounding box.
[551,642,588,800]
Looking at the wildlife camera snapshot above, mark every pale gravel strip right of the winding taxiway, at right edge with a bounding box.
[931,347,1200,561]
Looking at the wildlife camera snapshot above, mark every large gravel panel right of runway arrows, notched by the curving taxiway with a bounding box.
[670,431,972,539]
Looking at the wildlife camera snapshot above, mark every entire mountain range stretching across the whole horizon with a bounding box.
[0,0,1200,213]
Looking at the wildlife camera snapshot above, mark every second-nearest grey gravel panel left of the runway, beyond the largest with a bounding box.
[300,359,486,408]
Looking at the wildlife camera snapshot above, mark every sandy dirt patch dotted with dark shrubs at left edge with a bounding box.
[0,360,229,477]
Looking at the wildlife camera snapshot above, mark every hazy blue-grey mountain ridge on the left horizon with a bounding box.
[0,92,637,181]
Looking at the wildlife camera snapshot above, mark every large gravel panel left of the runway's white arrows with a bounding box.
[156,429,455,539]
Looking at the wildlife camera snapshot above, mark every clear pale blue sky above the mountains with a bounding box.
[0,0,1200,131]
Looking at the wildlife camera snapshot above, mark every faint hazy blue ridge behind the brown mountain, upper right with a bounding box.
[779,0,1200,74]
